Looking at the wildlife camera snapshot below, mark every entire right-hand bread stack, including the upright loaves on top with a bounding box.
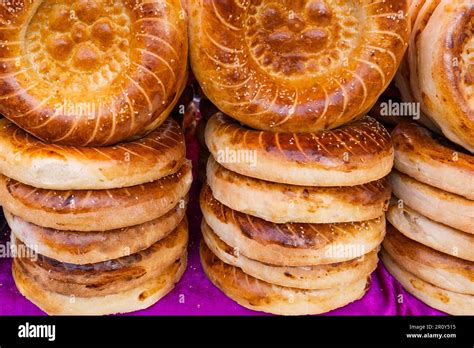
[382,0,474,315]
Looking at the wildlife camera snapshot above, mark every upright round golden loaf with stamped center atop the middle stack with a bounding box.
[189,0,409,132]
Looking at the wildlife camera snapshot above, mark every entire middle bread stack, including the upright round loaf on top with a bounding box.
[189,0,408,315]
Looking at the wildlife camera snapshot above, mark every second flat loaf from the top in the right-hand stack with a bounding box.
[390,170,474,234]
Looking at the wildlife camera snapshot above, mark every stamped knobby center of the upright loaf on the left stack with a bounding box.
[26,0,131,94]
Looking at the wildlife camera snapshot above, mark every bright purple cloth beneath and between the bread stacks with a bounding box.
[0,137,443,316]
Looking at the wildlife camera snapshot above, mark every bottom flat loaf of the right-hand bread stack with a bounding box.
[381,250,474,315]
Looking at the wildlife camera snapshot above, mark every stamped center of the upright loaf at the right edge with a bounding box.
[460,21,474,109]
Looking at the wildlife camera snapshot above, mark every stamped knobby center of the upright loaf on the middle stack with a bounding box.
[246,0,362,78]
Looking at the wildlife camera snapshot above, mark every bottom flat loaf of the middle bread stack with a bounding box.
[201,242,369,315]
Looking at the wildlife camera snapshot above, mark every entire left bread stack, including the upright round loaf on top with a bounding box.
[0,0,192,315]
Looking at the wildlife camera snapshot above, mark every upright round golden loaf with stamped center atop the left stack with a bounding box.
[0,0,188,146]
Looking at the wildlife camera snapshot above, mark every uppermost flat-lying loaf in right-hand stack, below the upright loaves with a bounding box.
[392,122,474,200]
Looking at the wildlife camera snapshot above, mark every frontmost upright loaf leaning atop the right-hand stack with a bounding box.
[410,0,474,152]
